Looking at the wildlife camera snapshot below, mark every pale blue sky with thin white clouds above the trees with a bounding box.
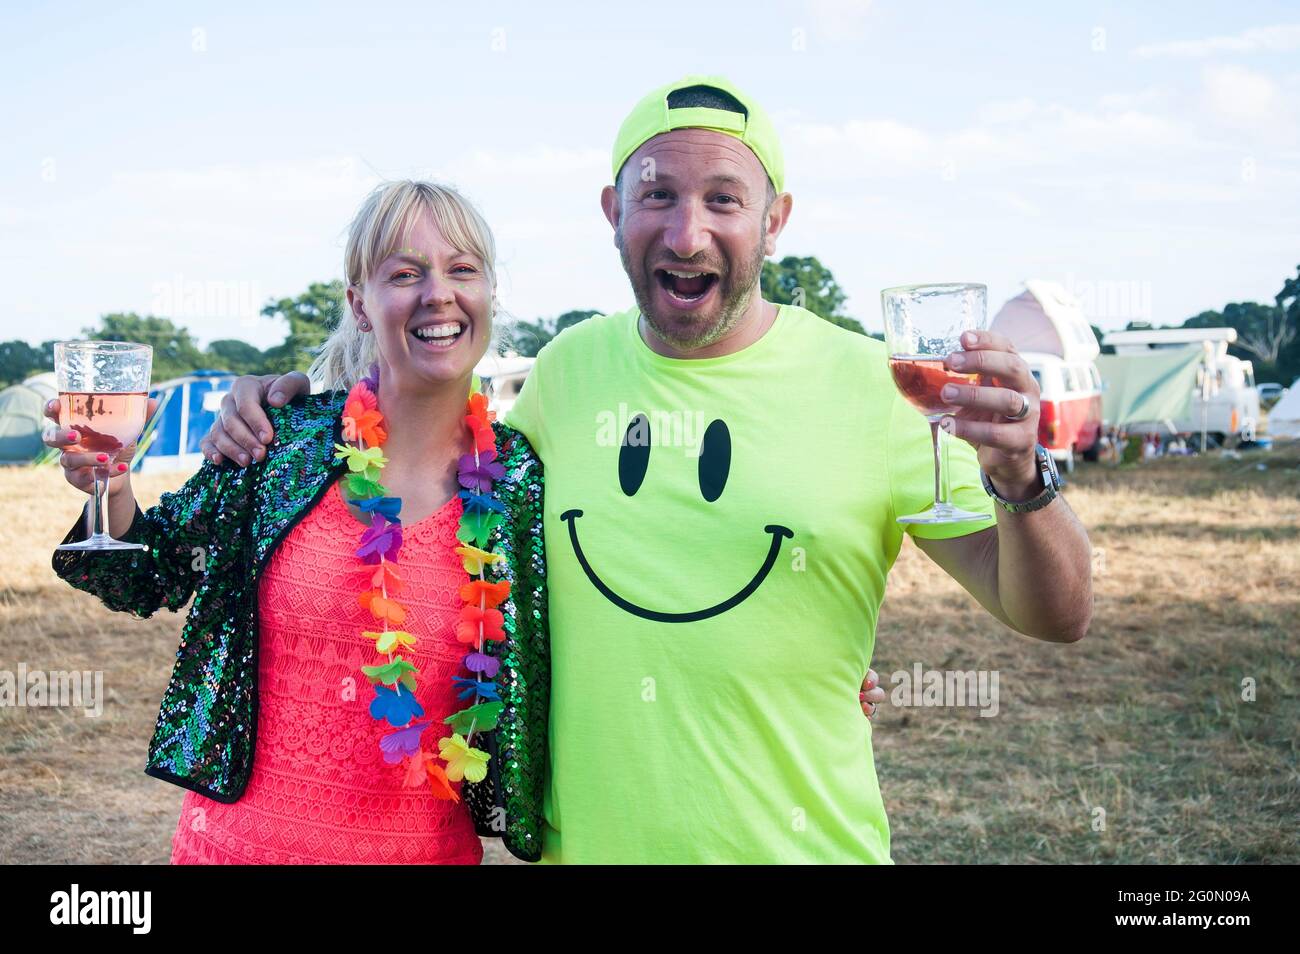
[0,0,1300,347]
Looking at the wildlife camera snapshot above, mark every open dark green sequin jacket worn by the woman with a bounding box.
[53,391,550,862]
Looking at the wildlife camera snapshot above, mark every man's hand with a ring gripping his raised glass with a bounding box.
[940,331,1043,500]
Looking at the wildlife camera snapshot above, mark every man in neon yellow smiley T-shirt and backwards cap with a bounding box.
[208,77,1092,863]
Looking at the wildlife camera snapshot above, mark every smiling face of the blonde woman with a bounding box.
[347,214,493,390]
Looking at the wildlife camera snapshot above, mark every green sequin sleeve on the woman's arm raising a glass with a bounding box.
[52,461,250,619]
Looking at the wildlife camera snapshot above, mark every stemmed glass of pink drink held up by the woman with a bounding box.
[55,342,153,550]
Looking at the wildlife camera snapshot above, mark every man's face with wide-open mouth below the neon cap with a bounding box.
[602,129,784,352]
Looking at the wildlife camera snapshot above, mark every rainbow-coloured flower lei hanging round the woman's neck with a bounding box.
[334,367,510,802]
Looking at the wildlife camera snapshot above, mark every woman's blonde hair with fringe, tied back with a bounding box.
[308,179,497,390]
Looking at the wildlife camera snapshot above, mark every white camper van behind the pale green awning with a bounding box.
[1104,328,1260,446]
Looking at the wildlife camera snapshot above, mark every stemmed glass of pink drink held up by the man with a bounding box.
[880,283,992,524]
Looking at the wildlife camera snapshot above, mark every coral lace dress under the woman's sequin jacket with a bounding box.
[172,482,482,864]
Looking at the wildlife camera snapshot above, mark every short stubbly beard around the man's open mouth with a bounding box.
[614,229,767,352]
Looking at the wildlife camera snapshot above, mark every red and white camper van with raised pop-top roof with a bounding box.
[989,279,1101,471]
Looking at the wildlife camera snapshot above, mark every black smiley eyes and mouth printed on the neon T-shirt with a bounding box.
[560,415,794,623]
